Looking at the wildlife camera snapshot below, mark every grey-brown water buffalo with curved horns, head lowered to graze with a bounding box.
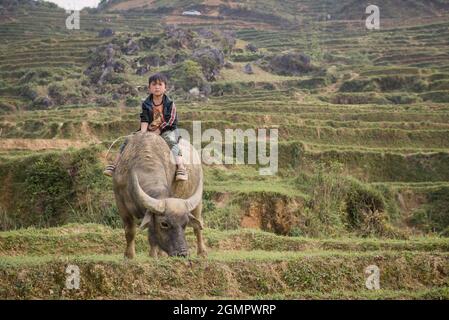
[113,132,206,259]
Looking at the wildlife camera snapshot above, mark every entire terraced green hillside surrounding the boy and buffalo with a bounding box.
[0,0,449,299]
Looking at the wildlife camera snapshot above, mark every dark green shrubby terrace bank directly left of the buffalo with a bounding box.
[0,147,121,228]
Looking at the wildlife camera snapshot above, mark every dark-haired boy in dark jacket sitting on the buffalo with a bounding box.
[103,73,188,181]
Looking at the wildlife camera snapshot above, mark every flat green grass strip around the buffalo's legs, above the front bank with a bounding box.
[0,223,449,259]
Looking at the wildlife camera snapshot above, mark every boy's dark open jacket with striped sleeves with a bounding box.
[140,94,178,133]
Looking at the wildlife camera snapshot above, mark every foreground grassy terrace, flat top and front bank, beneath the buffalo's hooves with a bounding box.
[0,224,449,299]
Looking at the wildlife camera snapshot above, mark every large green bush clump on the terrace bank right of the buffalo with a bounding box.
[292,162,405,238]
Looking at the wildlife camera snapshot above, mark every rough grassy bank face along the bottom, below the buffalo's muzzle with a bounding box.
[0,242,449,299]
